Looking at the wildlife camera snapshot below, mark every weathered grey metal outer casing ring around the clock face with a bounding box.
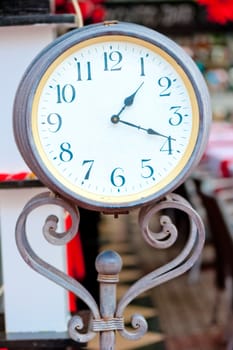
[14,22,211,212]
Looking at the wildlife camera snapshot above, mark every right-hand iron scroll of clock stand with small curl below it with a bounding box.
[116,194,205,339]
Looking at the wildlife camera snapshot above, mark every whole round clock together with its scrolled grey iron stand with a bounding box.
[14,21,211,350]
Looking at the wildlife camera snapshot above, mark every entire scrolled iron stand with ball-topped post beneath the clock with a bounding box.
[16,192,205,350]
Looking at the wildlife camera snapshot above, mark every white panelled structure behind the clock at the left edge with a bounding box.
[0,19,75,333]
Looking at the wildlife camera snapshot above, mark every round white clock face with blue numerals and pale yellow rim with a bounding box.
[14,26,211,211]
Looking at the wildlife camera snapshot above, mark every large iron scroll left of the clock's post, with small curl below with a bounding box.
[15,192,100,341]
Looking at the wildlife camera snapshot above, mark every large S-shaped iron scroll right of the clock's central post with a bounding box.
[116,194,205,330]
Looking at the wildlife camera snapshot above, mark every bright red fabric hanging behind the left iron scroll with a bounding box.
[65,215,85,313]
